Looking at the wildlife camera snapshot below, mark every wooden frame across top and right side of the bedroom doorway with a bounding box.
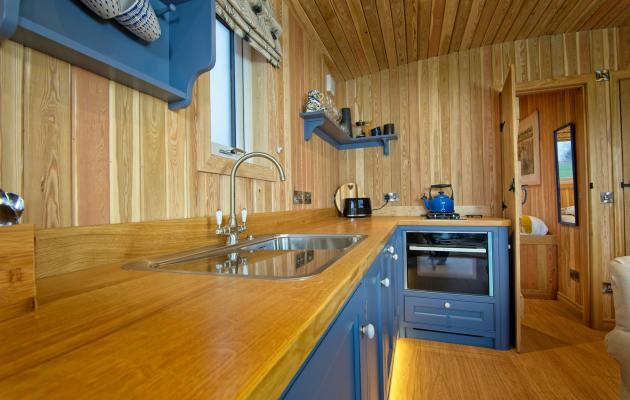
[516,73,599,326]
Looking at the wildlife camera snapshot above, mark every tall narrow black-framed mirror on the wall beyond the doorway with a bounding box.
[553,123,578,225]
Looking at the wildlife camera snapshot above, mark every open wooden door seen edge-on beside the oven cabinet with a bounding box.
[501,65,525,351]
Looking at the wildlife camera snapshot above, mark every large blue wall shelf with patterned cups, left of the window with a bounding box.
[0,0,215,109]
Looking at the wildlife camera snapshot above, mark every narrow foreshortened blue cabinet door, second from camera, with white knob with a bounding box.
[360,257,383,400]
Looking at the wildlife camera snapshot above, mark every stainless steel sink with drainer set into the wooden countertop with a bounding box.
[123,234,365,279]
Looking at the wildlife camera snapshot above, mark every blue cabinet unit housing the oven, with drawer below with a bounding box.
[397,226,510,350]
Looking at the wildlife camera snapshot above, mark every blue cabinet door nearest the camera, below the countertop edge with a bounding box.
[282,284,367,400]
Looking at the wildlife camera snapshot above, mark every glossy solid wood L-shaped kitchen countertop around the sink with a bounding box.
[0,217,510,399]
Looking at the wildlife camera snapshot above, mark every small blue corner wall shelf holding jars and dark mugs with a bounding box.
[300,111,398,156]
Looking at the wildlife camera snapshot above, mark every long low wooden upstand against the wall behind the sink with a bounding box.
[36,209,335,278]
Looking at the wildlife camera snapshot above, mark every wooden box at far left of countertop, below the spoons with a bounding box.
[0,224,35,322]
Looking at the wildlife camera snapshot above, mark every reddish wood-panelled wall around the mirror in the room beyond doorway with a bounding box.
[519,88,589,307]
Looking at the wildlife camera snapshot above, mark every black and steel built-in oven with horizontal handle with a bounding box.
[405,231,493,296]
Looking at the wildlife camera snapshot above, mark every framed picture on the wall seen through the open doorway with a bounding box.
[518,111,540,185]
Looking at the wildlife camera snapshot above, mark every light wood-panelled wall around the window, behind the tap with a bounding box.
[0,0,339,228]
